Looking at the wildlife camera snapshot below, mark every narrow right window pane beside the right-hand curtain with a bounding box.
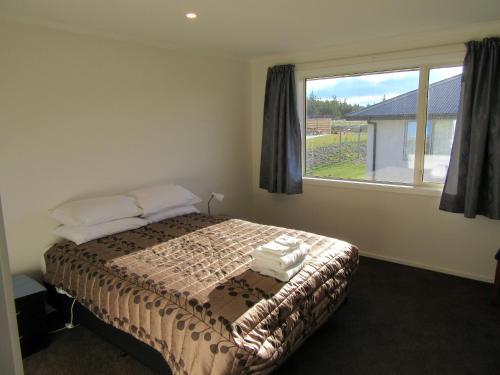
[424,66,462,183]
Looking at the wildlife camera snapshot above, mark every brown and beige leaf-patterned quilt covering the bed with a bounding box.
[44,214,358,375]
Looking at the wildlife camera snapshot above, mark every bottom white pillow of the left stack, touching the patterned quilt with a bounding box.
[54,217,148,245]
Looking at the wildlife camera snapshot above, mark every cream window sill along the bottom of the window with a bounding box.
[303,177,443,197]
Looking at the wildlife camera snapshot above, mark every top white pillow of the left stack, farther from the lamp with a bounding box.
[49,195,142,226]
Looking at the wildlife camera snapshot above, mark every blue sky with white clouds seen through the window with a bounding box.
[306,66,462,106]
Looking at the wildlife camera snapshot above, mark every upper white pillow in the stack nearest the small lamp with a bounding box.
[128,184,201,216]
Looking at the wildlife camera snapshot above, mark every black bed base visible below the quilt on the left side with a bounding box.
[45,284,172,375]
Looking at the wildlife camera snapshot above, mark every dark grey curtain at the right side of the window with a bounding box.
[439,38,500,220]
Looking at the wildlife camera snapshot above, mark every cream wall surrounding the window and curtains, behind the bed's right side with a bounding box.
[251,22,500,281]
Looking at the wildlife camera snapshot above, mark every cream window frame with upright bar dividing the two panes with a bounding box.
[295,47,465,196]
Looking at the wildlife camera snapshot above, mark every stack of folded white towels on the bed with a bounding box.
[250,235,310,281]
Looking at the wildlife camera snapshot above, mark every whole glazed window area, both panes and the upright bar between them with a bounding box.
[304,67,462,185]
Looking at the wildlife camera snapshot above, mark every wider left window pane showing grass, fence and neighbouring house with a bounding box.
[306,70,419,184]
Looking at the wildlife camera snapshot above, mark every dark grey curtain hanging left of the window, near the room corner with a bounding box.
[259,65,302,194]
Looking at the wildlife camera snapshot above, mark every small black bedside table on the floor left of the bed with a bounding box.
[12,275,49,357]
